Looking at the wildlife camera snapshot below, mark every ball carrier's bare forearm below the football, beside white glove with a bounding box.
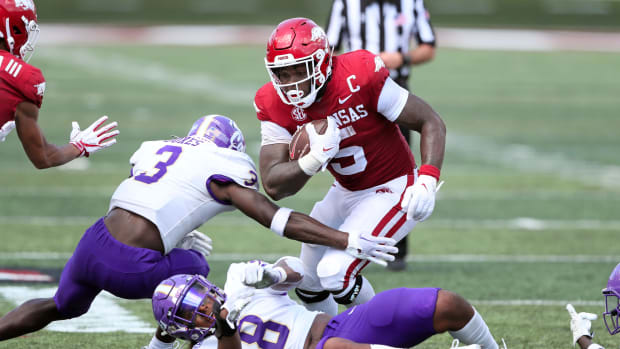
[262,161,310,200]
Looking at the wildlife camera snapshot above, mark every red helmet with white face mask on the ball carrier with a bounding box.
[265,18,332,108]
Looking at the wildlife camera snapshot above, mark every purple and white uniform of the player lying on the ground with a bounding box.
[193,257,439,349]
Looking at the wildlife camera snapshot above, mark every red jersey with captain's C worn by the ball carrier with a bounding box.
[254,50,415,190]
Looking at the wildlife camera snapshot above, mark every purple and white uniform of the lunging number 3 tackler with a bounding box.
[54,137,258,318]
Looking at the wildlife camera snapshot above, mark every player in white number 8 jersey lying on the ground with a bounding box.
[147,257,498,349]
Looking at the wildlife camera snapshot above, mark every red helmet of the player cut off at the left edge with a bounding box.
[0,0,39,61]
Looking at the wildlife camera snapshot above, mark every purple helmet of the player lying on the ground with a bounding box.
[153,274,226,342]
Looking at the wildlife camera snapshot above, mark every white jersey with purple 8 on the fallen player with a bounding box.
[224,263,320,349]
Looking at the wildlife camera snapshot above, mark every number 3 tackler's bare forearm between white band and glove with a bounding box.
[284,212,349,250]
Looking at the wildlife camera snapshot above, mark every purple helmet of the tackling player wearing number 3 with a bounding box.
[187,114,245,152]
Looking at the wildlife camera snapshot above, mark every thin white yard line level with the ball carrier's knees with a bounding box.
[0,252,620,264]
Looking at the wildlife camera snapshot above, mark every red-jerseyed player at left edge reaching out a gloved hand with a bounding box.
[0,0,119,169]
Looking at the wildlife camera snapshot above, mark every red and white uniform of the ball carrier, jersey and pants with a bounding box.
[254,50,415,300]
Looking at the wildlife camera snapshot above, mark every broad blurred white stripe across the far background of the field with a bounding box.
[39,24,620,52]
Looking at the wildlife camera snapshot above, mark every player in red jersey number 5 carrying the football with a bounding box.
[254,18,446,315]
